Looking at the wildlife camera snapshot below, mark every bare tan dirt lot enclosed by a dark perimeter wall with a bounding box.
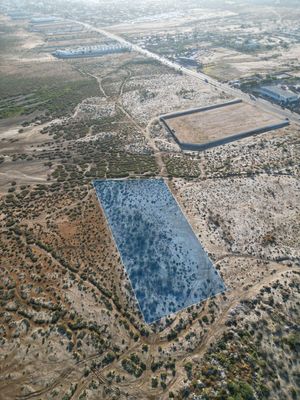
[166,102,282,144]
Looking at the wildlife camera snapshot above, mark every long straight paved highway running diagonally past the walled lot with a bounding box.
[68,20,300,125]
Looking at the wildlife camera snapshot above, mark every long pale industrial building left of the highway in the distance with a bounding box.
[52,44,130,58]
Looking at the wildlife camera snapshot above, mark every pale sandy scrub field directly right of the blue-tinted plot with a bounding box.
[173,175,300,260]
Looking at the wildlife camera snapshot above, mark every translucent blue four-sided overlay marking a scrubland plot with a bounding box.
[94,179,225,323]
